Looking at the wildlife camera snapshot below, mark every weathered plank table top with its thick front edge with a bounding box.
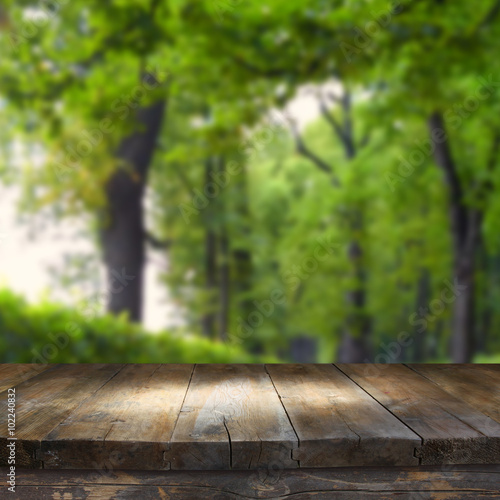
[0,364,500,470]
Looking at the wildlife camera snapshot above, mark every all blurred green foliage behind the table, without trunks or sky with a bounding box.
[0,0,500,362]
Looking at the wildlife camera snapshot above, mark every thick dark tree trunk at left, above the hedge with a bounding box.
[101,92,165,321]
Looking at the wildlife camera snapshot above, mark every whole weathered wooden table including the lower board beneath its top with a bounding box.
[0,364,500,500]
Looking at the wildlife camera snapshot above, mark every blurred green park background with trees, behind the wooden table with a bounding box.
[0,0,500,363]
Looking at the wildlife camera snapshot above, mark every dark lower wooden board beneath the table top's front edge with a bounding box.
[6,466,500,500]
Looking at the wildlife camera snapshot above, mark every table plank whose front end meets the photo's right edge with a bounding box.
[337,364,500,465]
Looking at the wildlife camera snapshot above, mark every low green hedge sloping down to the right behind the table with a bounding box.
[0,290,273,363]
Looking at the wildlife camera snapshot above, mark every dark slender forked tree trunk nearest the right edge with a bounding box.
[429,112,481,363]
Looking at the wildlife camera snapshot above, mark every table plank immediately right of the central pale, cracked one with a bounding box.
[267,364,421,467]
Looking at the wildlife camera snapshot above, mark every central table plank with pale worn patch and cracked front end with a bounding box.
[169,365,297,470]
